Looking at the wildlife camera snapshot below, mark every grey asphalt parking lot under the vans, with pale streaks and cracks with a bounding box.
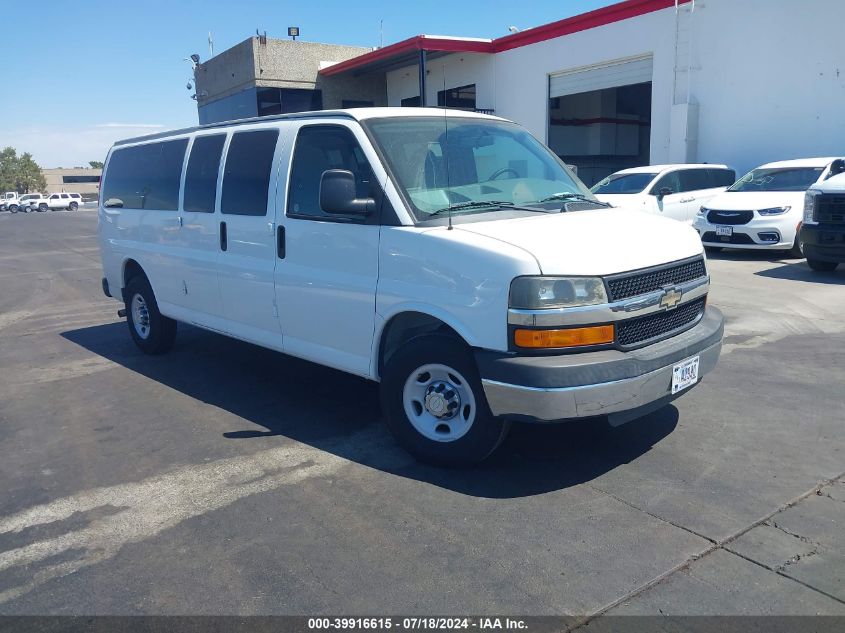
[0,209,845,626]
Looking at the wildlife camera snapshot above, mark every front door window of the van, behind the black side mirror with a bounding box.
[287,125,374,219]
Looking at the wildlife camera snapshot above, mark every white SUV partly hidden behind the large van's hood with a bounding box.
[591,163,736,224]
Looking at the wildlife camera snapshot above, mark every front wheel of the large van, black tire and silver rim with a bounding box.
[381,335,509,465]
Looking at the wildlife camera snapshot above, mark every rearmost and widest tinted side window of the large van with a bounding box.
[102,138,188,211]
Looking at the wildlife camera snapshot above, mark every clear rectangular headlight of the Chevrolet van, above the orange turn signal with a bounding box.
[510,277,607,310]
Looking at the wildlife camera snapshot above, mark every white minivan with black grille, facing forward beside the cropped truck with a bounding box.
[693,158,841,257]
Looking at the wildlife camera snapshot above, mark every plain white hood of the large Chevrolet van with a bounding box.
[455,209,702,275]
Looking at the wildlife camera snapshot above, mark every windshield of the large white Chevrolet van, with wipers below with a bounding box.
[364,116,604,222]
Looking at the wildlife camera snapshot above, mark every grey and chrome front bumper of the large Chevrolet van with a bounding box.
[476,307,724,424]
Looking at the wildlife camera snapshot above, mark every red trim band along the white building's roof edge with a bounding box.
[320,0,691,76]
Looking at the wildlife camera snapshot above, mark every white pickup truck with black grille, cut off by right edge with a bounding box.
[801,159,845,272]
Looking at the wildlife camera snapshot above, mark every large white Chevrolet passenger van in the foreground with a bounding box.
[99,108,723,464]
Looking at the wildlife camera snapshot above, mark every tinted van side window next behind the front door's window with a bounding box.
[220,130,279,215]
